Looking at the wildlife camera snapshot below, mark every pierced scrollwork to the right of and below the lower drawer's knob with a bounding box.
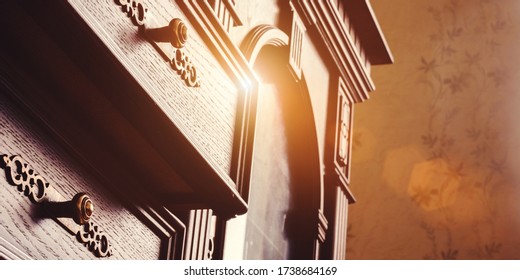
[76,222,112,257]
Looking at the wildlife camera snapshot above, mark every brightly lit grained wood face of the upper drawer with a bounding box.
[71,0,239,179]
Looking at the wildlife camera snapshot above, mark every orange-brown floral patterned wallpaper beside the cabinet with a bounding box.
[347,0,520,259]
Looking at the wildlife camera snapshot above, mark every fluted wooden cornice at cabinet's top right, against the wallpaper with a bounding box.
[293,0,392,103]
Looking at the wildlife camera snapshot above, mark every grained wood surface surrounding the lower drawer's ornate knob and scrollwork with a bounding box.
[0,92,161,259]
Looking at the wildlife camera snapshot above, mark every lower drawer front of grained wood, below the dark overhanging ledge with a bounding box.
[0,92,182,259]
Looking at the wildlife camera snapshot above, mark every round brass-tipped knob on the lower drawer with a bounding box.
[45,193,94,225]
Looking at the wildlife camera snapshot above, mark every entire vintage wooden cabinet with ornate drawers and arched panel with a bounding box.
[0,0,392,259]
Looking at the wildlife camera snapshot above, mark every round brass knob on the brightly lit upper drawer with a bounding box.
[144,18,188,49]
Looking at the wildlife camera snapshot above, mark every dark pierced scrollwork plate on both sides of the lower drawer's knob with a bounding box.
[0,154,112,257]
